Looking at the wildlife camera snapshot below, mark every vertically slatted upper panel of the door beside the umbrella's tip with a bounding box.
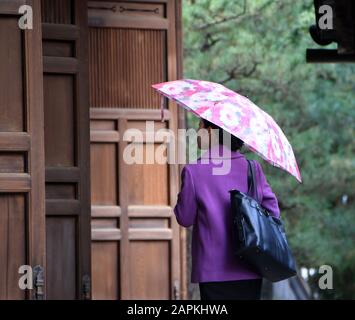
[89,28,166,109]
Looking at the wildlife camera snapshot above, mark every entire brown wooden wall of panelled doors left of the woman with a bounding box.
[0,0,184,299]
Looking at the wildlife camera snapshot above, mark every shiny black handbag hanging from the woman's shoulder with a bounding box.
[229,160,297,282]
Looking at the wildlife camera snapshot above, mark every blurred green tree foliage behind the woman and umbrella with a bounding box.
[184,0,355,298]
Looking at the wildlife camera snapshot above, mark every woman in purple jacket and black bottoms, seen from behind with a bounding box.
[174,119,280,300]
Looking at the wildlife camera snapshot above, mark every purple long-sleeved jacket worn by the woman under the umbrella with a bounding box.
[174,145,280,283]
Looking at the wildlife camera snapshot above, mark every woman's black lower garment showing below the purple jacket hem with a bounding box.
[199,279,262,300]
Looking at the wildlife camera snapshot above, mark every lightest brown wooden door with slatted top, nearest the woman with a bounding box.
[88,0,181,299]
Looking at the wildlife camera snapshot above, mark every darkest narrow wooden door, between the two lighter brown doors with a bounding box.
[42,0,91,299]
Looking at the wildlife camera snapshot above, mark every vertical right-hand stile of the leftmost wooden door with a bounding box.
[25,0,46,298]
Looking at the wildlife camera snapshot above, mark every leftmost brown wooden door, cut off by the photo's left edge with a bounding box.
[0,0,45,299]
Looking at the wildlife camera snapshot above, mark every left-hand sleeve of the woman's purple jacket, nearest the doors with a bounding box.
[174,166,197,227]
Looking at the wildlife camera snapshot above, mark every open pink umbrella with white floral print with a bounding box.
[152,79,302,182]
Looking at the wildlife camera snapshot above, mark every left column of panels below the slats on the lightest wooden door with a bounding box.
[90,119,122,300]
